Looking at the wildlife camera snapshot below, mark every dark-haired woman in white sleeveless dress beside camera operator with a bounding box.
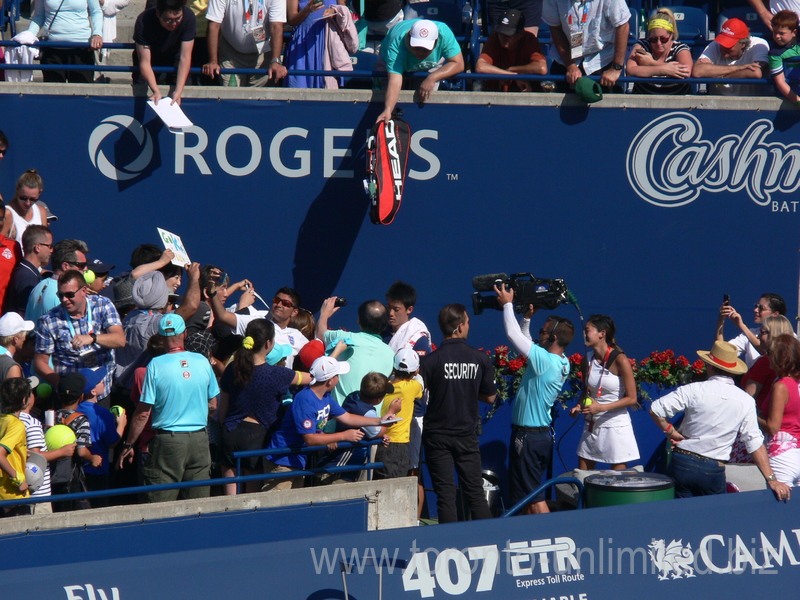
[570,315,639,470]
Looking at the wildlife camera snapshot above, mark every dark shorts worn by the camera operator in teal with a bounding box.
[508,428,553,505]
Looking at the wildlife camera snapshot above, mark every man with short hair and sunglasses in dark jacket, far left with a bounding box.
[3,225,53,316]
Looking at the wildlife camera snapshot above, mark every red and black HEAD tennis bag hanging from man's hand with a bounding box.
[365,116,411,225]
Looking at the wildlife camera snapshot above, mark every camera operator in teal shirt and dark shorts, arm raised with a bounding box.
[494,285,575,514]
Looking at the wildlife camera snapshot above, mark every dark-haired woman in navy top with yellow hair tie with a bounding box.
[218,319,311,495]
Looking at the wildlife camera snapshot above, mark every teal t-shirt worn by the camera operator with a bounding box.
[512,344,569,427]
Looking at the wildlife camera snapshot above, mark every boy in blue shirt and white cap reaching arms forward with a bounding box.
[262,356,381,491]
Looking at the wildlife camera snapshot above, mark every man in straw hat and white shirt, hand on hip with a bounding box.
[650,341,790,500]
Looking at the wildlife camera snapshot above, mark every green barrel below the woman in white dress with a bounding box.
[583,471,675,508]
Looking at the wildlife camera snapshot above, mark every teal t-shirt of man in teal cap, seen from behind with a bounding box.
[140,352,219,431]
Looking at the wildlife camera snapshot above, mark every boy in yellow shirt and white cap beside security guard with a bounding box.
[374,348,422,479]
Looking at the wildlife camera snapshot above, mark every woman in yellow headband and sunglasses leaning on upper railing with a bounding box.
[626,8,694,94]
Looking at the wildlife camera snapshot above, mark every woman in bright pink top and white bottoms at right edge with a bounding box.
[758,334,800,486]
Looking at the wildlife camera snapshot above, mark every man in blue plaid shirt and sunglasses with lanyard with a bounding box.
[33,270,125,408]
